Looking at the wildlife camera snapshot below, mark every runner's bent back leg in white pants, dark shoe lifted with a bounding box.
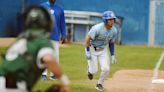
[88,55,98,80]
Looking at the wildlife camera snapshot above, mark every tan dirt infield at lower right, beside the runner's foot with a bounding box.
[105,70,164,92]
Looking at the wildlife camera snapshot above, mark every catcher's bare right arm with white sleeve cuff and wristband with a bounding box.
[37,46,69,92]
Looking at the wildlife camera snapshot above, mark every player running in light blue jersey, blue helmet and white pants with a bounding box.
[85,11,117,91]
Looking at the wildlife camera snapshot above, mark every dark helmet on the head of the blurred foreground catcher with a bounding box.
[23,6,53,31]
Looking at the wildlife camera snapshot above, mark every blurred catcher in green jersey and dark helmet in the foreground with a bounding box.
[0,6,69,92]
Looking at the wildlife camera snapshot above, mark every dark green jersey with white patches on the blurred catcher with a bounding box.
[0,37,55,90]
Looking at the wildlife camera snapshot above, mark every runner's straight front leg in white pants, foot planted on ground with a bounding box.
[96,49,110,91]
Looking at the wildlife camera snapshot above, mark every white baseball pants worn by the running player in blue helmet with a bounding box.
[88,47,110,85]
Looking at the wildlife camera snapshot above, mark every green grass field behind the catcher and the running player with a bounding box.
[2,44,164,92]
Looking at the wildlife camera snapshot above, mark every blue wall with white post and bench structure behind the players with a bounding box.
[0,0,164,46]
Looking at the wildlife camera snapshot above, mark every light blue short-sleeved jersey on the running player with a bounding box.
[88,23,117,49]
